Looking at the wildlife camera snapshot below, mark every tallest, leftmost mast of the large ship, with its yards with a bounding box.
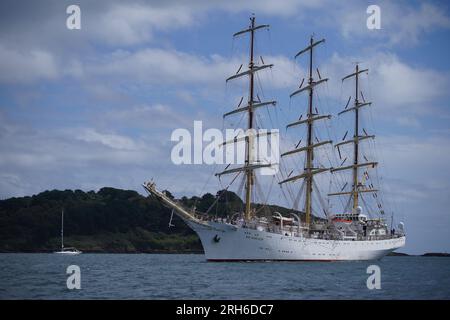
[216,16,276,221]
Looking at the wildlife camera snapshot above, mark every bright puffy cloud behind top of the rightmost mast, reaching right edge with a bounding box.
[324,53,450,117]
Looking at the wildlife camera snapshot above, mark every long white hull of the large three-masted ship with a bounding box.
[185,220,405,261]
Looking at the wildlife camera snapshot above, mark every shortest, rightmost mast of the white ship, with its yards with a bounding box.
[329,64,378,210]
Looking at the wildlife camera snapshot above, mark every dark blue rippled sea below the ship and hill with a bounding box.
[0,253,450,300]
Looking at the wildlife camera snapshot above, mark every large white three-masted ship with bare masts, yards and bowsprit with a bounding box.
[143,17,406,261]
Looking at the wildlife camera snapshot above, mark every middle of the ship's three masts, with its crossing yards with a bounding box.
[280,37,332,228]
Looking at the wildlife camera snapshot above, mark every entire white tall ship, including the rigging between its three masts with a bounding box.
[143,16,406,261]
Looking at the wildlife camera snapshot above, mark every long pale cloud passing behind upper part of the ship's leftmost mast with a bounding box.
[86,48,297,88]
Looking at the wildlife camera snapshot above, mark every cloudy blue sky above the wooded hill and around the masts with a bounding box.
[0,0,450,254]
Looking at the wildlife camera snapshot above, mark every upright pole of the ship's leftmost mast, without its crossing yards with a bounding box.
[245,17,255,221]
